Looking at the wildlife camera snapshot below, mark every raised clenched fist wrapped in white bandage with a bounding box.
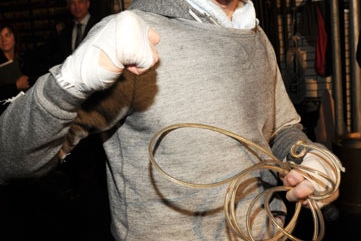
[57,11,160,95]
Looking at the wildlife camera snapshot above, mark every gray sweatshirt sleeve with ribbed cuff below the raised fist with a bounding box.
[0,66,84,184]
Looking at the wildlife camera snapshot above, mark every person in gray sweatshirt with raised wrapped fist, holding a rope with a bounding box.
[0,0,341,241]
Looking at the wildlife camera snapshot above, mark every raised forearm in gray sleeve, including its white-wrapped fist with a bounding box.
[0,11,159,184]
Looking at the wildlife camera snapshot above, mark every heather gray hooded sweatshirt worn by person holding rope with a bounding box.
[0,0,316,241]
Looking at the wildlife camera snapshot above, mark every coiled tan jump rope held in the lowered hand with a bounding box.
[149,123,344,241]
